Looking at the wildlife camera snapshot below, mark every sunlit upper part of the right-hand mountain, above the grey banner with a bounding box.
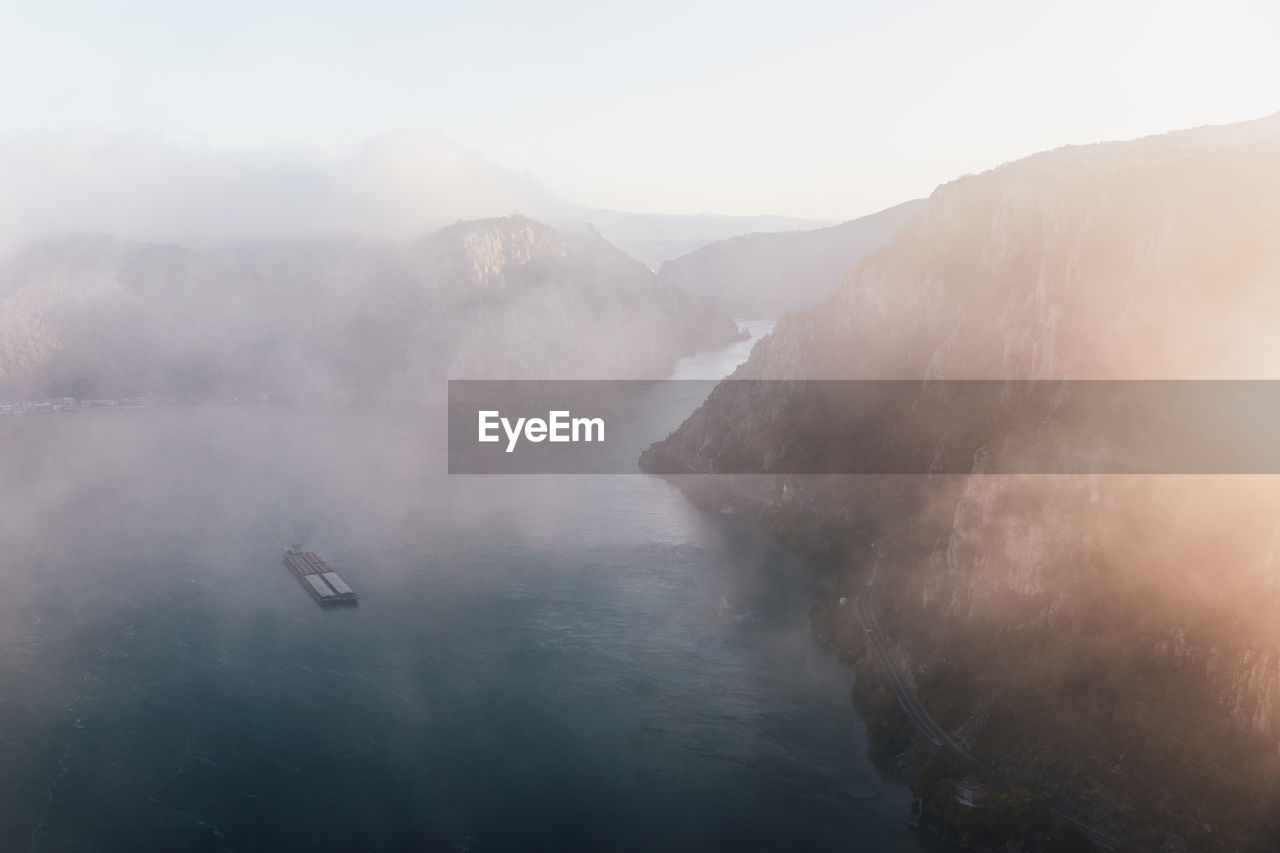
[756,112,1280,379]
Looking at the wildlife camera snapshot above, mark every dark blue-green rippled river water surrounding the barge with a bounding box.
[0,325,932,850]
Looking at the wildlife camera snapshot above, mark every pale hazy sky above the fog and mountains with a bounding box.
[0,0,1280,219]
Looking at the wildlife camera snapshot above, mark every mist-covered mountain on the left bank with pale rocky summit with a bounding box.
[0,216,737,398]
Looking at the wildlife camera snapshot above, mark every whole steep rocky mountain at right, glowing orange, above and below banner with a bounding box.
[646,117,1280,850]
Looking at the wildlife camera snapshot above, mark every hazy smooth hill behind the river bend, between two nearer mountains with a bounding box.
[658,200,924,318]
